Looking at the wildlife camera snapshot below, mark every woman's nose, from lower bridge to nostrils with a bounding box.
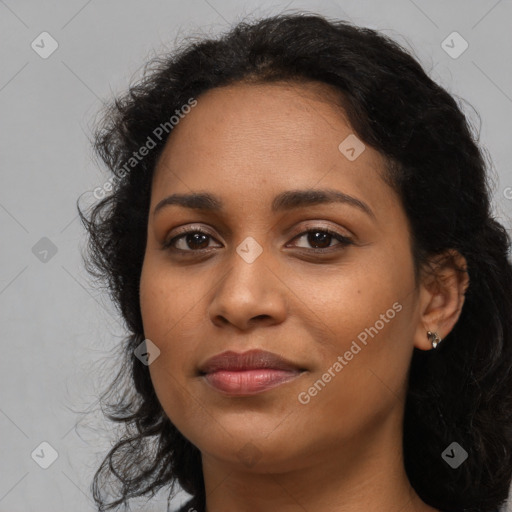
[209,245,287,330]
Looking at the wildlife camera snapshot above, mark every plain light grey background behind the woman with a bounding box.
[0,0,512,512]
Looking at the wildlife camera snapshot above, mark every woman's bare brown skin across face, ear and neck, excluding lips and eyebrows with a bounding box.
[140,83,468,512]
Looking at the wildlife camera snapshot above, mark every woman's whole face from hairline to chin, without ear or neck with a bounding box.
[140,83,424,471]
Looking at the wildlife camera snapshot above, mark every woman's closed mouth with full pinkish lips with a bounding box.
[199,350,306,396]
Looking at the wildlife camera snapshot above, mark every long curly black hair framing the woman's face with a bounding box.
[77,13,512,512]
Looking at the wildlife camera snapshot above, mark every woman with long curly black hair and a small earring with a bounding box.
[81,15,512,512]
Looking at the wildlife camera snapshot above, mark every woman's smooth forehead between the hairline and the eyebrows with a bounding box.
[152,82,396,218]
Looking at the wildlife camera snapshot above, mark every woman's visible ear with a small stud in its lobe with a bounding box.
[414,249,469,350]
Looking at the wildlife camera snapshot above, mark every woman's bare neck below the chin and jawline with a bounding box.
[202,406,437,512]
